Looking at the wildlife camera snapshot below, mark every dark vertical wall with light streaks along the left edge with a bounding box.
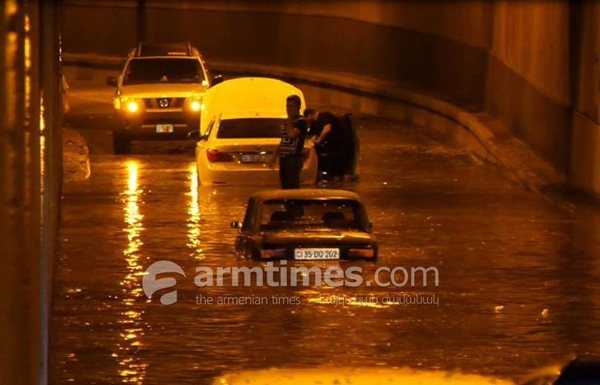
[0,2,62,384]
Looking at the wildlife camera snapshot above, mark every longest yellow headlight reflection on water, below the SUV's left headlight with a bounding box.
[112,161,148,384]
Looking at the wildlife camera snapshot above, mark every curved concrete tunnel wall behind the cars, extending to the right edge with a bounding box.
[63,0,600,192]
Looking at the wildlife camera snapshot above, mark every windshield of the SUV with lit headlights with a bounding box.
[123,58,204,85]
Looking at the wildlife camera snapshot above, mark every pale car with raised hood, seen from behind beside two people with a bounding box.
[196,78,318,185]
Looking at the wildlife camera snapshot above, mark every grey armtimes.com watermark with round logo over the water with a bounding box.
[142,260,440,306]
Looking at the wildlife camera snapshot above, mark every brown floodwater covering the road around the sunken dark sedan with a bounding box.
[51,118,600,384]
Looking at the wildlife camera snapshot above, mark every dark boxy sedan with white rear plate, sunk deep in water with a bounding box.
[231,189,378,260]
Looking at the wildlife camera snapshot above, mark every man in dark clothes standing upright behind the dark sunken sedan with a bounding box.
[278,95,308,189]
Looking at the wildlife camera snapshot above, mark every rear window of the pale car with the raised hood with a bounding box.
[217,118,285,139]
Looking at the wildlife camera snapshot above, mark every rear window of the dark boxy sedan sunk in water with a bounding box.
[260,199,367,231]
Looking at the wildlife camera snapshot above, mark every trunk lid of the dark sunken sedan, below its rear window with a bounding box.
[262,230,374,245]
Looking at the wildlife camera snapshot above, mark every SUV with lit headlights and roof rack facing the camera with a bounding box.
[106,43,210,152]
